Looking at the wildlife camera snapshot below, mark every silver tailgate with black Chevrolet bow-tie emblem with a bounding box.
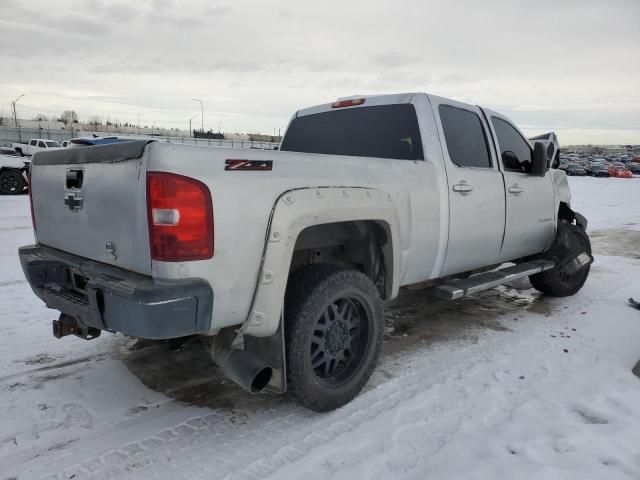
[31,140,151,275]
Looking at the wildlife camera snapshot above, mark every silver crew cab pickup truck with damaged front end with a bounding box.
[20,93,593,411]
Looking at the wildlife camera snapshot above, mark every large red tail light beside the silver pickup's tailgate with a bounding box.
[147,172,213,262]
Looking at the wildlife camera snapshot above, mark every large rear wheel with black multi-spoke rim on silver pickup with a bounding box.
[285,264,384,412]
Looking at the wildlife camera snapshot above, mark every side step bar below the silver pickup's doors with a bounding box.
[430,260,555,300]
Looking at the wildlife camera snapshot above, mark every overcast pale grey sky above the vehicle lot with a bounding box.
[0,0,640,144]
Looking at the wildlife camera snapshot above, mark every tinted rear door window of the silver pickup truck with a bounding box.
[438,105,491,168]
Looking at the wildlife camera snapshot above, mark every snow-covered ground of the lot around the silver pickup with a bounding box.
[0,177,640,480]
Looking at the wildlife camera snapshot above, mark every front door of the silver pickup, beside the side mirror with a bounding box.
[485,110,556,262]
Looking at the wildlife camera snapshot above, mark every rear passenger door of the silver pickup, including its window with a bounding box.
[429,95,505,276]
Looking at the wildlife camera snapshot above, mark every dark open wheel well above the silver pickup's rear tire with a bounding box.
[289,220,393,299]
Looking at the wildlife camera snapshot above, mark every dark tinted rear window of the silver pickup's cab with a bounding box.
[281,104,424,160]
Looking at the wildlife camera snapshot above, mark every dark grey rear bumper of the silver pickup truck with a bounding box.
[19,245,213,339]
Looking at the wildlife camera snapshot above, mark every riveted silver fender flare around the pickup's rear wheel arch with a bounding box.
[240,187,401,337]
